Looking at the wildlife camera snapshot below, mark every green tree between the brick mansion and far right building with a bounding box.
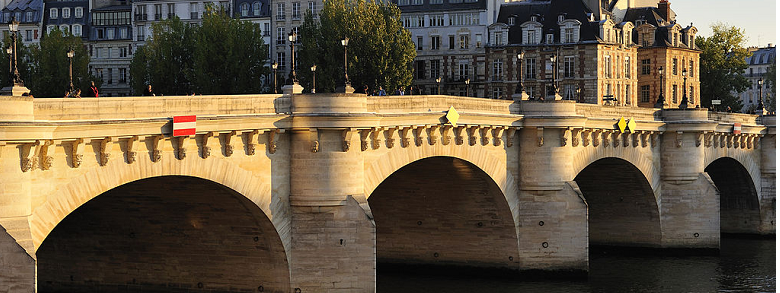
[696,23,750,110]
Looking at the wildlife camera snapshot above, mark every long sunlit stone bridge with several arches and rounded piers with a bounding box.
[0,94,775,292]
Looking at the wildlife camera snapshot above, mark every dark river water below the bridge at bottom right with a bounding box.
[377,238,776,293]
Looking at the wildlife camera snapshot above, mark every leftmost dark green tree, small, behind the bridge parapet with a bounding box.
[22,29,97,97]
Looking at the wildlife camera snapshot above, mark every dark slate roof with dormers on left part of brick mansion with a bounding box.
[496,0,598,44]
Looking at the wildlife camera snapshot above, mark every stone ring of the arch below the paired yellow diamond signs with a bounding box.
[572,145,661,198]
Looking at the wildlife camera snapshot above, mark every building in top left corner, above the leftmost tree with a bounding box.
[0,0,43,45]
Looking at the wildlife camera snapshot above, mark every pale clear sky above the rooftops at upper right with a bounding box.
[669,0,777,47]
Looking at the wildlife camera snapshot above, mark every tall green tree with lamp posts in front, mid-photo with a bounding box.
[298,0,417,92]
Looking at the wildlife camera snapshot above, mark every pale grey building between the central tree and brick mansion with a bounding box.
[393,0,500,97]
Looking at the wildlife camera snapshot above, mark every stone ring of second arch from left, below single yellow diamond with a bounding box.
[363,143,520,224]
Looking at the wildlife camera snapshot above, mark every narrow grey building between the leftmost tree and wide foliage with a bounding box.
[89,1,133,97]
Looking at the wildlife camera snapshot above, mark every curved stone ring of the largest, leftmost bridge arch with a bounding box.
[30,157,290,256]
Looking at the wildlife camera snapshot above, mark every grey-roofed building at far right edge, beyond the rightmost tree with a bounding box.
[739,44,776,113]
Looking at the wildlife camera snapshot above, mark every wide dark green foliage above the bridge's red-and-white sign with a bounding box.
[130,7,269,95]
